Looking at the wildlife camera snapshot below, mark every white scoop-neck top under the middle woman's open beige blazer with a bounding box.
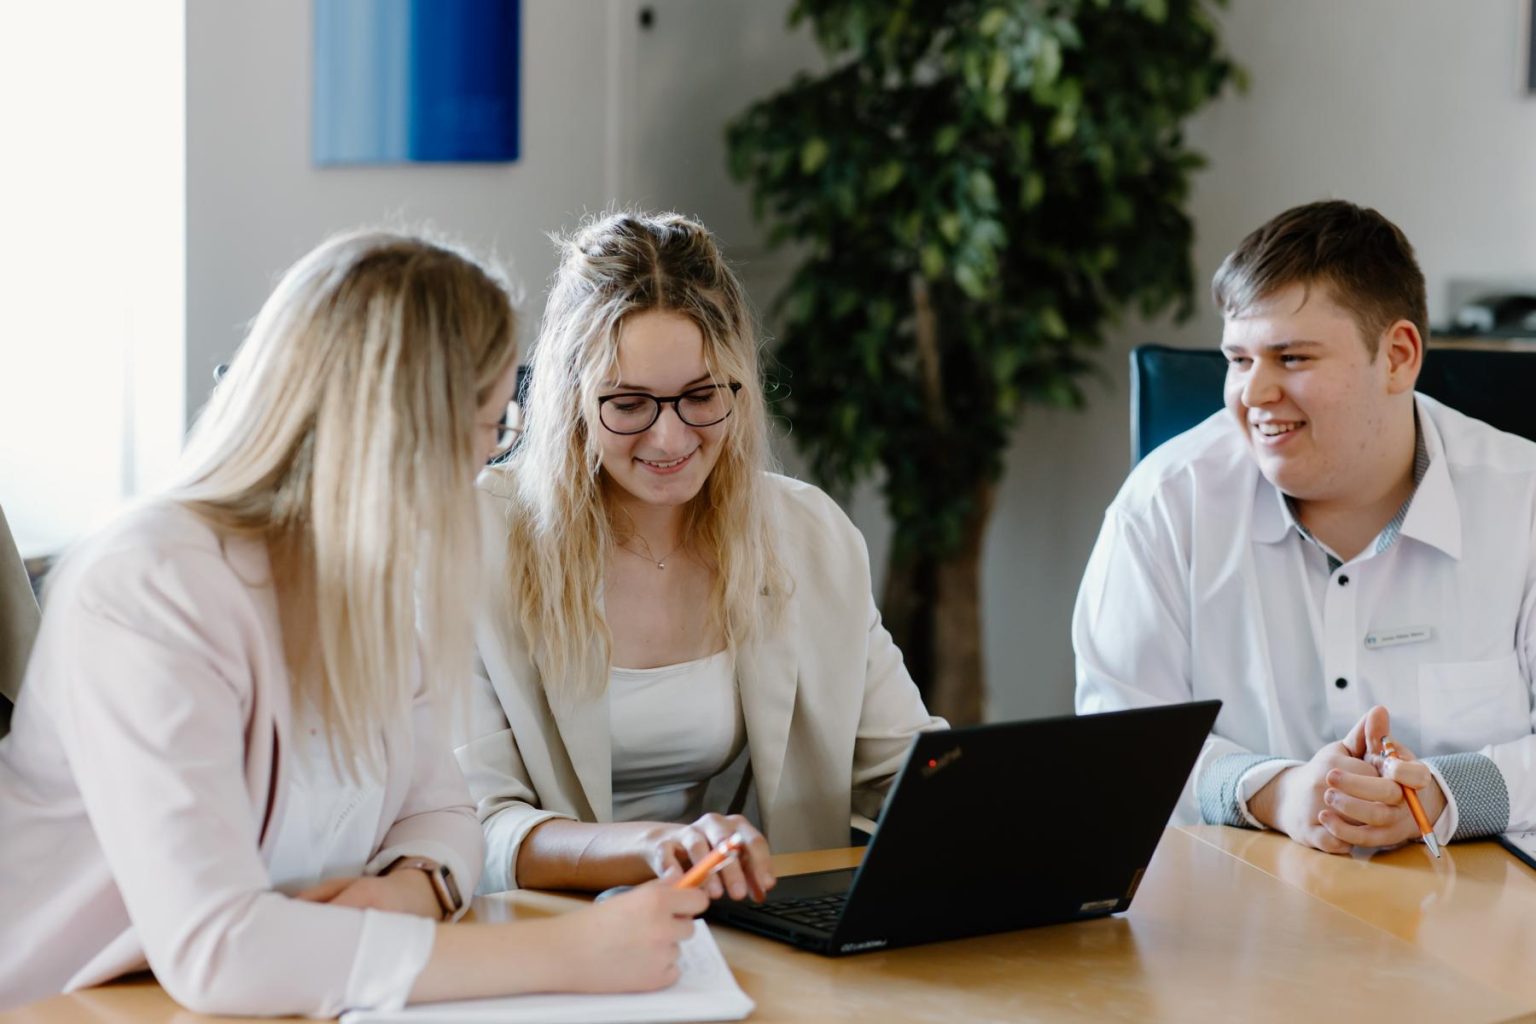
[608,651,746,821]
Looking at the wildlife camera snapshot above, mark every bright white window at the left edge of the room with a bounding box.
[0,0,186,556]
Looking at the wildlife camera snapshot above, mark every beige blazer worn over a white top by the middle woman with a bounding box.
[456,471,945,892]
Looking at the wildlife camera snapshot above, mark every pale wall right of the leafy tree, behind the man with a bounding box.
[985,0,1536,717]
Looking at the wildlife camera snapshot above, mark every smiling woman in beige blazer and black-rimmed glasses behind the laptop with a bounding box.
[458,213,942,898]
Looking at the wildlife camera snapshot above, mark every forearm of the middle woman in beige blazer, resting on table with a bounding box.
[515,818,663,889]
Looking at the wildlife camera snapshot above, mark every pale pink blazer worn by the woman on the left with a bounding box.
[0,504,482,1016]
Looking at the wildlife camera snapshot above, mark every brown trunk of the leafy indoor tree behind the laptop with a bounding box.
[882,484,995,725]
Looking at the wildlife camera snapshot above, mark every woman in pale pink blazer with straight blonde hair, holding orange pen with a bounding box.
[0,233,707,1015]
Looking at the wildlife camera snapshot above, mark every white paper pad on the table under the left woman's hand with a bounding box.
[341,921,754,1024]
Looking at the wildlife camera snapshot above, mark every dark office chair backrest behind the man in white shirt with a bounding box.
[1130,345,1536,465]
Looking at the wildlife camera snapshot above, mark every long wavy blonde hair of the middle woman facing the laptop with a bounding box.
[482,213,790,703]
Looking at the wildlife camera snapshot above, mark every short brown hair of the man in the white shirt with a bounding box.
[1210,200,1430,359]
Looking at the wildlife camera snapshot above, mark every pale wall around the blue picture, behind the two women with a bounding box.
[187,0,817,411]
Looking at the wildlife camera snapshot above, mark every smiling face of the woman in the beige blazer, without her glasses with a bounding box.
[593,310,731,508]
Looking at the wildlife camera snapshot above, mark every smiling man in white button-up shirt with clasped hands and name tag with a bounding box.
[1072,201,1536,854]
